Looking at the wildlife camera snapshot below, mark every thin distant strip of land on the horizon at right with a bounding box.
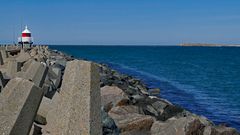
[179,43,240,47]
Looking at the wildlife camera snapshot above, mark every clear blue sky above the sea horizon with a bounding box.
[0,0,240,45]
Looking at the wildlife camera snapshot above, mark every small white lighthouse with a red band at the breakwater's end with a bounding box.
[18,26,33,47]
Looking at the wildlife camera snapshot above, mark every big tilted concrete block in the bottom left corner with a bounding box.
[0,78,43,135]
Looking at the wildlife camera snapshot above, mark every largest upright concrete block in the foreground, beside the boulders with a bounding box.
[46,60,102,135]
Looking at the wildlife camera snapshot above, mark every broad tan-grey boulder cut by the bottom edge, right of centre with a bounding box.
[151,117,205,135]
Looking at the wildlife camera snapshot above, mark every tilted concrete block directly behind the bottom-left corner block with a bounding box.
[25,61,48,87]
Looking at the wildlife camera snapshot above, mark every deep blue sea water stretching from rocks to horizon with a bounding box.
[50,45,240,130]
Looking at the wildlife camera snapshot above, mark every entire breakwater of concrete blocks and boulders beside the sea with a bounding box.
[0,46,238,135]
